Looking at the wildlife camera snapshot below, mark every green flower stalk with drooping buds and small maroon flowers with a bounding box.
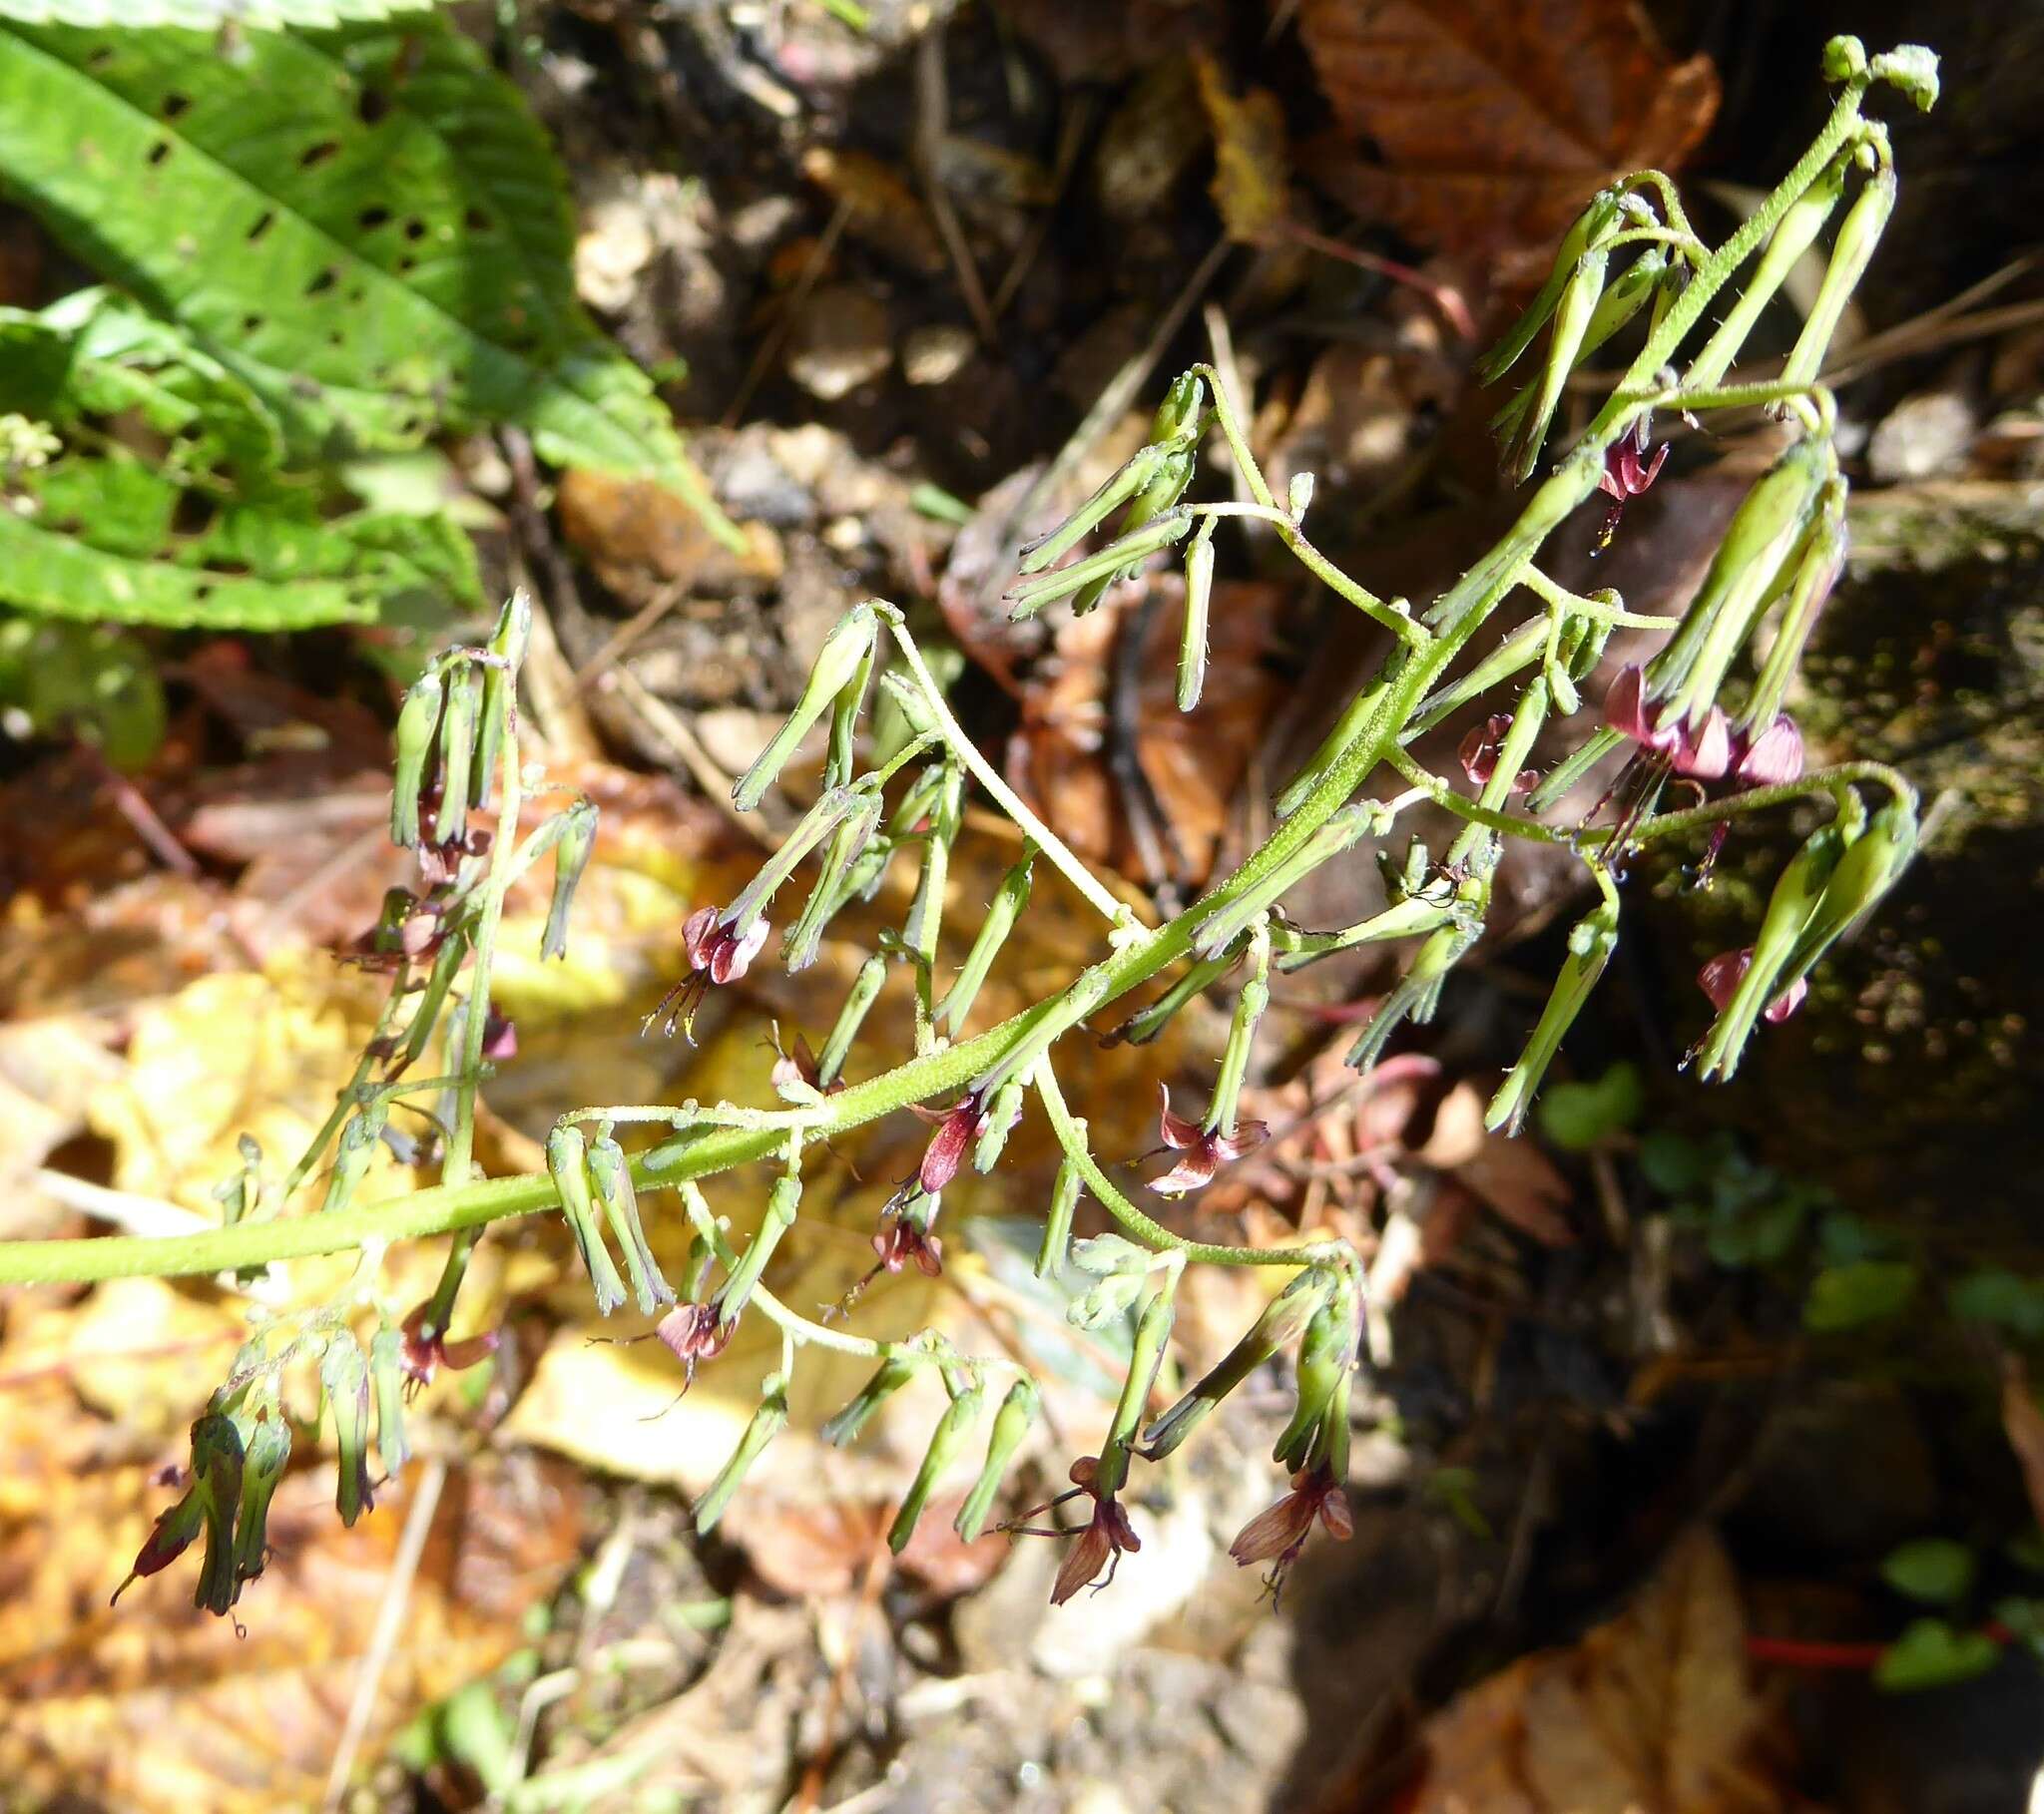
[0,39,1935,1611]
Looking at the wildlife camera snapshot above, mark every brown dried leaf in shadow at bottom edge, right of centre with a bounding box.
[1402,1530,1788,1814]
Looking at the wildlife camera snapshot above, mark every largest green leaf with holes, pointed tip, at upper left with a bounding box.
[0,14,736,537]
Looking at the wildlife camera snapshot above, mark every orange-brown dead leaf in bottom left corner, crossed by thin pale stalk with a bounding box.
[0,1461,581,1814]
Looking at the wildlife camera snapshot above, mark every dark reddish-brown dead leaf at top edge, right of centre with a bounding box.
[1297,0,1719,257]
